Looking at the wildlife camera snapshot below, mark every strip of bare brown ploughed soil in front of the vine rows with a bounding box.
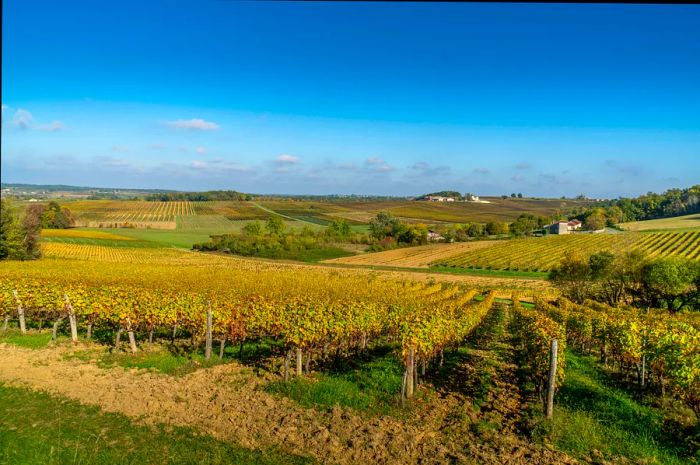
[0,338,575,465]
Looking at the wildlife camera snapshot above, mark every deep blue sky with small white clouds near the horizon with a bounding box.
[0,0,700,198]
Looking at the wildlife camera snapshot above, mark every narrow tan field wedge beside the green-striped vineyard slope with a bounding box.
[326,241,496,268]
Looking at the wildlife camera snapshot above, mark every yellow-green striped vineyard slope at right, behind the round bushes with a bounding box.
[433,231,700,271]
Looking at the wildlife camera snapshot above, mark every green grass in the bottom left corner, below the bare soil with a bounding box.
[0,384,315,465]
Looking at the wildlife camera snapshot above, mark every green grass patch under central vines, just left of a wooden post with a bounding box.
[265,346,403,414]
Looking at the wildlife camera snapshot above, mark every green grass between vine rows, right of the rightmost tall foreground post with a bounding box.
[540,351,698,465]
